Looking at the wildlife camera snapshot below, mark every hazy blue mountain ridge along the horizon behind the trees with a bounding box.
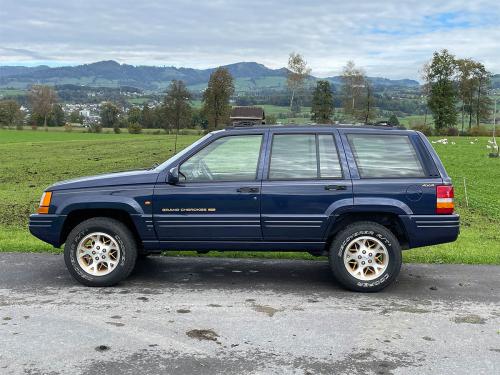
[0,60,420,91]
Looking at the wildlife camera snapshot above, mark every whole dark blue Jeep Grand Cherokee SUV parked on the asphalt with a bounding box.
[29,126,459,291]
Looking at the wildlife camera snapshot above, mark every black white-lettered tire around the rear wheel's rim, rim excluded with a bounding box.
[329,221,402,292]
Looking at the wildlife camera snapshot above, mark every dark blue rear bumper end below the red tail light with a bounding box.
[400,214,460,248]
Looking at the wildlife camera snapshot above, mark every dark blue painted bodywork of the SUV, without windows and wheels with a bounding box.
[29,126,459,254]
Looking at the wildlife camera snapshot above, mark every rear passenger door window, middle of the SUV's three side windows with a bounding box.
[269,134,342,180]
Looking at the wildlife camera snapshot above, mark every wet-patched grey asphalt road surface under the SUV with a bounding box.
[0,253,500,374]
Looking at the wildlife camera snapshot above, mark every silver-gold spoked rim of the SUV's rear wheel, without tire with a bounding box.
[344,236,389,281]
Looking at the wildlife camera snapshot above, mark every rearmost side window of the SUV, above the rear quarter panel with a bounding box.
[347,134,425,178]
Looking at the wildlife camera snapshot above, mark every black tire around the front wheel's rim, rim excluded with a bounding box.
[64,217,137,287]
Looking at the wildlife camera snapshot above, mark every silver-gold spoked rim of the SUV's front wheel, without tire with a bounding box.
[77,232,121,276]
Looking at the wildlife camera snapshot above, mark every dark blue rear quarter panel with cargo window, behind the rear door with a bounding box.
[341,129,442,215]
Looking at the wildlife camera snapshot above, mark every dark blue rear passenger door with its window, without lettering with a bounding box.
[261,128,352,242]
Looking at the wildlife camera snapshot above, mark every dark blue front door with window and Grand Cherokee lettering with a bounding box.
[153,133,263,241]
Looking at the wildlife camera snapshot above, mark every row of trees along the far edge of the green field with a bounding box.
[0,50,492,134]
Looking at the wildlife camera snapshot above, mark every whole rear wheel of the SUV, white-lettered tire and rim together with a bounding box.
[329,222,401,292]
